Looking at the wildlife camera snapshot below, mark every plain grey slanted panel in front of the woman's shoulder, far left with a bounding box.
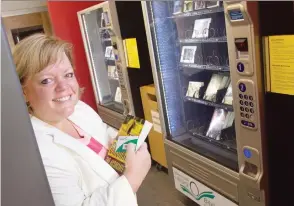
[1,21,55,206]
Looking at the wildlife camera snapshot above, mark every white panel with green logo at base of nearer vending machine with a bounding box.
[173,167,237,206]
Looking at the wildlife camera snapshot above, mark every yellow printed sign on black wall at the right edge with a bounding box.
[269,35,294,95]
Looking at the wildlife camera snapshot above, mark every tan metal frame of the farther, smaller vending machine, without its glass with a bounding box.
[78,1,134,129]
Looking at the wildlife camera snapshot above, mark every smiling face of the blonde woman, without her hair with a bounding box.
[23,54,79,122]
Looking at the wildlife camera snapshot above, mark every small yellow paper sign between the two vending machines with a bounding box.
[123,38,140,69]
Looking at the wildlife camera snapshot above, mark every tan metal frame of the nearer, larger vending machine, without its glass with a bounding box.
[142,1,268,206]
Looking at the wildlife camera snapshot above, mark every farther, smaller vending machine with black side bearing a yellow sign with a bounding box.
[78,1,153,128]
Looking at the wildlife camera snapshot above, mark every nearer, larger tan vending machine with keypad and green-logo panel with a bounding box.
[142,1,268,206]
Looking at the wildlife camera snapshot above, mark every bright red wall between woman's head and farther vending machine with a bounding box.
[48,1,101,111]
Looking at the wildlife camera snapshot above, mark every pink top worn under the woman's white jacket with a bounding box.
[72,123,107,159]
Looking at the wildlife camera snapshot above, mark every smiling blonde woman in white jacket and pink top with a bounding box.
[13,34,151,206]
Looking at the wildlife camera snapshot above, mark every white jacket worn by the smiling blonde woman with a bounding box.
[31,101,137,206]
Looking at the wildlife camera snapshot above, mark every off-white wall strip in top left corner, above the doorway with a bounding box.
[1,1,47,17]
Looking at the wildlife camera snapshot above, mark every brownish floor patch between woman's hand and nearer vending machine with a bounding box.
[137,166,197,206]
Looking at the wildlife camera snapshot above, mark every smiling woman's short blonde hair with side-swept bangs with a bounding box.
[12,33,74,86]
